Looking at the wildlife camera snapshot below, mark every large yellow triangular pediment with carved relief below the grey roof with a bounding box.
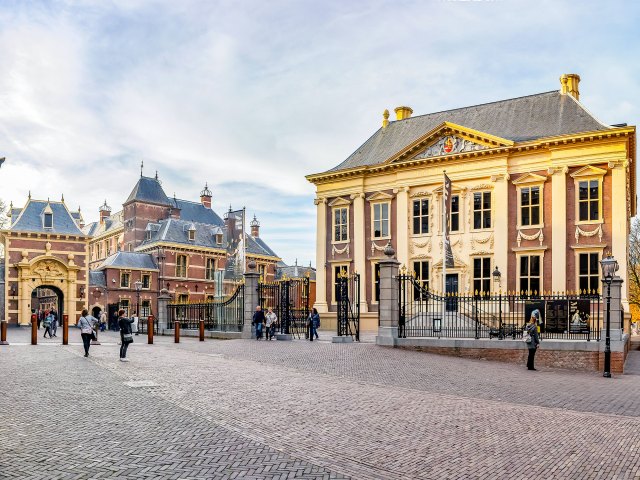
[388,122,513,163]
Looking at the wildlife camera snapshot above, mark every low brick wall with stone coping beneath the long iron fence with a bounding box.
[376,335,629,374]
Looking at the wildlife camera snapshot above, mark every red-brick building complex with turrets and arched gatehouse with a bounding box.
[0,175,286,325]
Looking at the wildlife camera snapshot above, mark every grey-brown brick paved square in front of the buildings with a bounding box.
[0,330,640,479]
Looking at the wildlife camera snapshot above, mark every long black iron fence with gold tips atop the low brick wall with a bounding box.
[398,274,603,341]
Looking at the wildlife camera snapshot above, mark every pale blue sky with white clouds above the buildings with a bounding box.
[0,0,640,266]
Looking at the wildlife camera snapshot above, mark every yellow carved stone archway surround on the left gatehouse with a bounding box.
[16,255,81,325]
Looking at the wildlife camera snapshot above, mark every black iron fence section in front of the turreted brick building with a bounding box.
[167,285,244,332]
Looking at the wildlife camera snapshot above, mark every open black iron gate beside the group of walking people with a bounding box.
[258,278,309,338]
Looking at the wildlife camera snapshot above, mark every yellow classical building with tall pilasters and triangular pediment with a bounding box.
[307,74,636,328]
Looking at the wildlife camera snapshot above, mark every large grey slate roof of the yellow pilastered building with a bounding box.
[329,90,610,172]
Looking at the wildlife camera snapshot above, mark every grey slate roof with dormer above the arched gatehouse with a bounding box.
[11,199,83,235]
